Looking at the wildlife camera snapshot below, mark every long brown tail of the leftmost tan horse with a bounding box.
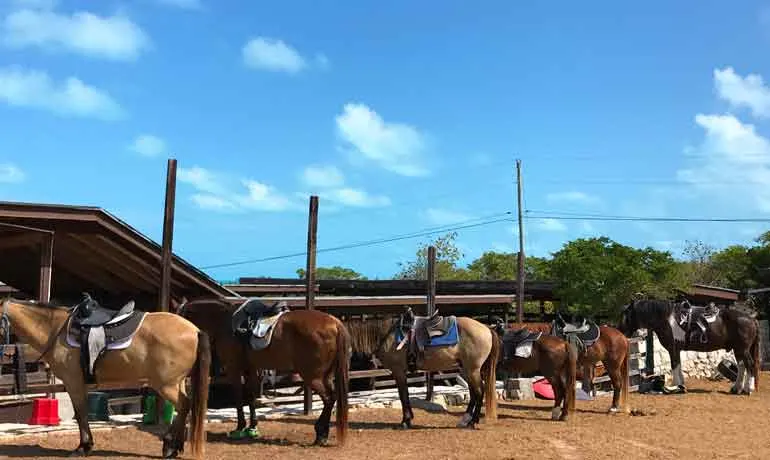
[190,331,211,458]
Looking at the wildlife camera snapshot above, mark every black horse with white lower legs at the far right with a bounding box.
[618,299,760,394]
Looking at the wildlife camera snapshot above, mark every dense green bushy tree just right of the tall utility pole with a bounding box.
[550,237,686,316]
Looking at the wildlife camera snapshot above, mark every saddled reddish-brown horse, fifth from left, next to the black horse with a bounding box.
[512,315,630,413]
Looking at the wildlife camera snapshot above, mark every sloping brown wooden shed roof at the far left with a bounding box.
[0,202,237,303]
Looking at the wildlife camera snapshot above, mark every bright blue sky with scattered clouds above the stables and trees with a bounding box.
[0,0,770,279]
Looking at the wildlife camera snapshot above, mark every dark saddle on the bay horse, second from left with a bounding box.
[232,299,289,350]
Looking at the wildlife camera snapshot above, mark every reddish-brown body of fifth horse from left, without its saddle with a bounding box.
[512,323,630,413]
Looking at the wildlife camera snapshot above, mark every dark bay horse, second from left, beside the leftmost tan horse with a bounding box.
[179,299,350,445]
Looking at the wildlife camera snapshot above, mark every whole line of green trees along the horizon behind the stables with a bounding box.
[297,231,770,317]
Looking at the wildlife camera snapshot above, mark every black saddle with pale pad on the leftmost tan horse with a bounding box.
[67,294,146,384]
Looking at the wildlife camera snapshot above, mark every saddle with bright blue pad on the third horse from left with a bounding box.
[396,308,458,372]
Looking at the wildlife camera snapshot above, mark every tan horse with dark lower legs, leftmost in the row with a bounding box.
[0,298,211,458]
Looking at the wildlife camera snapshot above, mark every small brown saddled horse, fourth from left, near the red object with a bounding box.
[490,318,577,421]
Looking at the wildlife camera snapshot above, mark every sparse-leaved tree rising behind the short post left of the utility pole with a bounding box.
[396,232,470,280]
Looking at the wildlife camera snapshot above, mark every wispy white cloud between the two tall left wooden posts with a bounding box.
[177,166,298,211]
